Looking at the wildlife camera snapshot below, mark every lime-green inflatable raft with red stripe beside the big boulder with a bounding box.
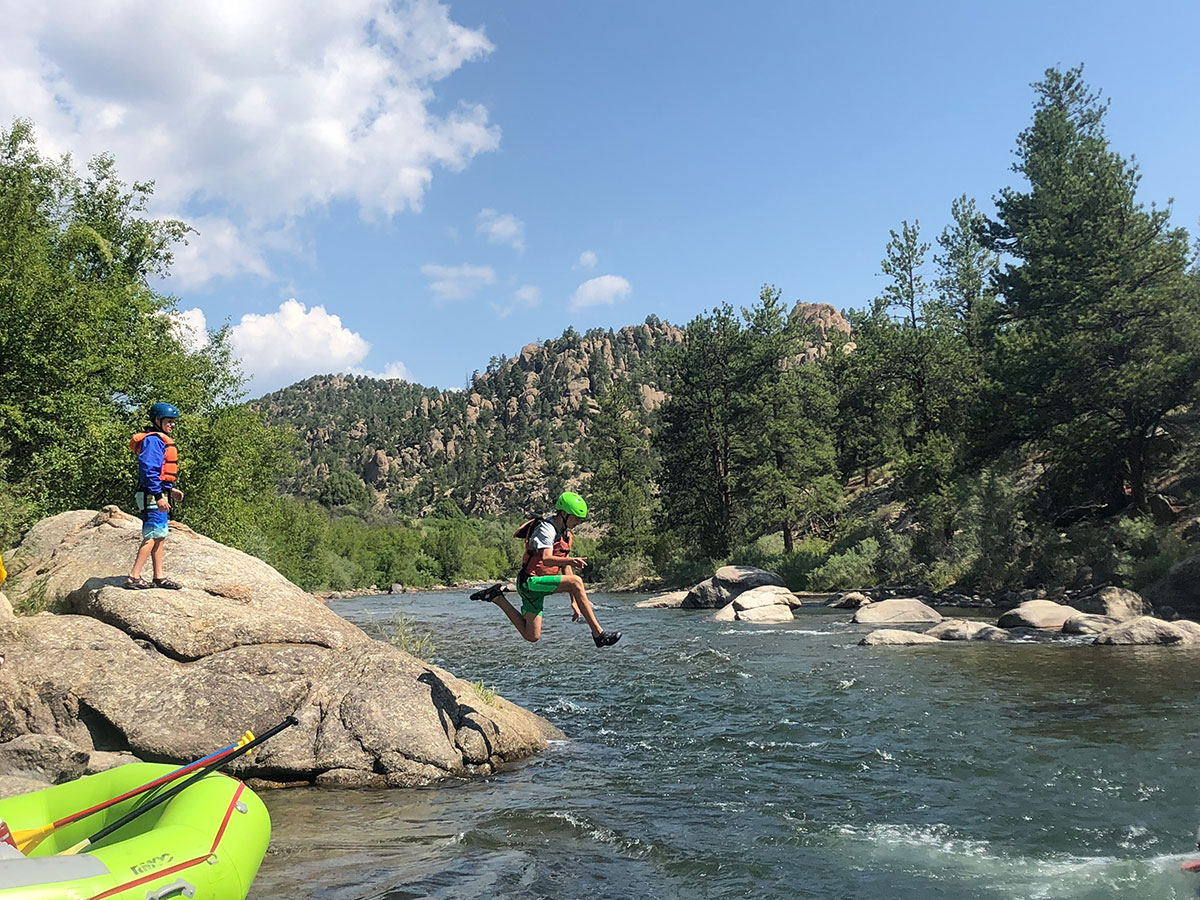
[0,762,271,900]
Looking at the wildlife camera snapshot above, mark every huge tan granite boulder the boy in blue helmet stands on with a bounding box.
[0,508,560,786]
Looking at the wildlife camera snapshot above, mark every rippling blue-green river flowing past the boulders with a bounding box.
[250,593,1200,900]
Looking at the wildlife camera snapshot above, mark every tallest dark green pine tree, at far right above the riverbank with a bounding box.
[989,67,1200,510]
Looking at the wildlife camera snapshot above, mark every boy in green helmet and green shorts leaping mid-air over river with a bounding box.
[470,491,620,647]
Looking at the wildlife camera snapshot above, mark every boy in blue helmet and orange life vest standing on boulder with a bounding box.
[121,403,184,590]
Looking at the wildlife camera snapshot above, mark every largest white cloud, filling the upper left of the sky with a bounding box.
[0,0,500,284]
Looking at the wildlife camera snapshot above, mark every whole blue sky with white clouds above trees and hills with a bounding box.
[0,0,1200,395]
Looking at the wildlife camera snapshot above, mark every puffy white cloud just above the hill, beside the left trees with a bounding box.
[229,299,371,391]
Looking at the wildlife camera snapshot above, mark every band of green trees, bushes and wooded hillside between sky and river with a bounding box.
[0,68,1200,592]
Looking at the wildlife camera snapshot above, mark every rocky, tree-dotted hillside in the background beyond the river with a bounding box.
[254,304,850,515]
